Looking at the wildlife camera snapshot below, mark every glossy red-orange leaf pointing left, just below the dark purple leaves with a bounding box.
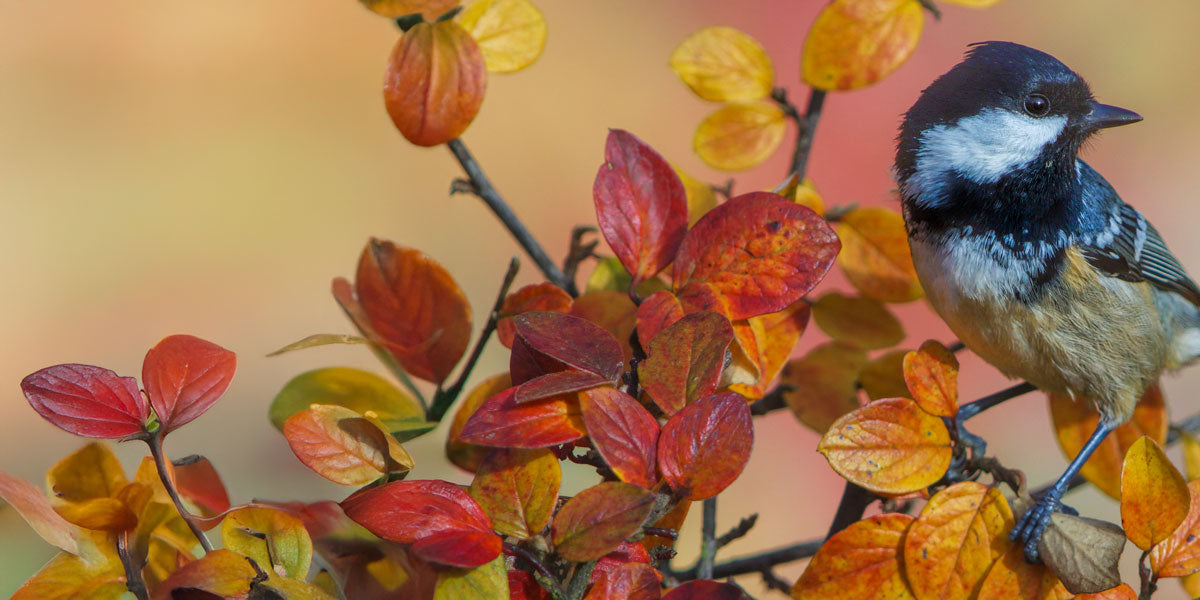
[458,388,584,448]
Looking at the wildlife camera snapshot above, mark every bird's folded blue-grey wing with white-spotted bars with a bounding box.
[1080,166,1200,306]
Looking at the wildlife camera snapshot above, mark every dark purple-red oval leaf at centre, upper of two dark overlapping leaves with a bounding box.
[512,312,624,383]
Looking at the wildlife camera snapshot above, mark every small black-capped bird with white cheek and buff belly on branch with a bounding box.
[894,42,1200,563]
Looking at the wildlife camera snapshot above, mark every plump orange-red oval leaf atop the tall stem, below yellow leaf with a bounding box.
[383,20,487,146]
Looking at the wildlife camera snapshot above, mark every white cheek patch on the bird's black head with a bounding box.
[904,108,1067,206]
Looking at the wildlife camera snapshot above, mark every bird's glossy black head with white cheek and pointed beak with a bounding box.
[895,42,1141,205]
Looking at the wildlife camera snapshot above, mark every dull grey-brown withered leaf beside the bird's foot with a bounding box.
[1038,512,1126,594]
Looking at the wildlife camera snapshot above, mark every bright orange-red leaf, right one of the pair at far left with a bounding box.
[142,335,238,433]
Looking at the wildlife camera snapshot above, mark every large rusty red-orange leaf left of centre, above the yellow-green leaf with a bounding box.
[354,237,470,383]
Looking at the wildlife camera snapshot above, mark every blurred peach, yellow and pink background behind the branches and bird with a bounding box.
[0,0,1200,598]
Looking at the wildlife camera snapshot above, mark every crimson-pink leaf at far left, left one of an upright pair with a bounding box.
[20,364,150,439]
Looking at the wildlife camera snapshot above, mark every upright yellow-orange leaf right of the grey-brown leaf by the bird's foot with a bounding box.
[1121,436,1192,551]
